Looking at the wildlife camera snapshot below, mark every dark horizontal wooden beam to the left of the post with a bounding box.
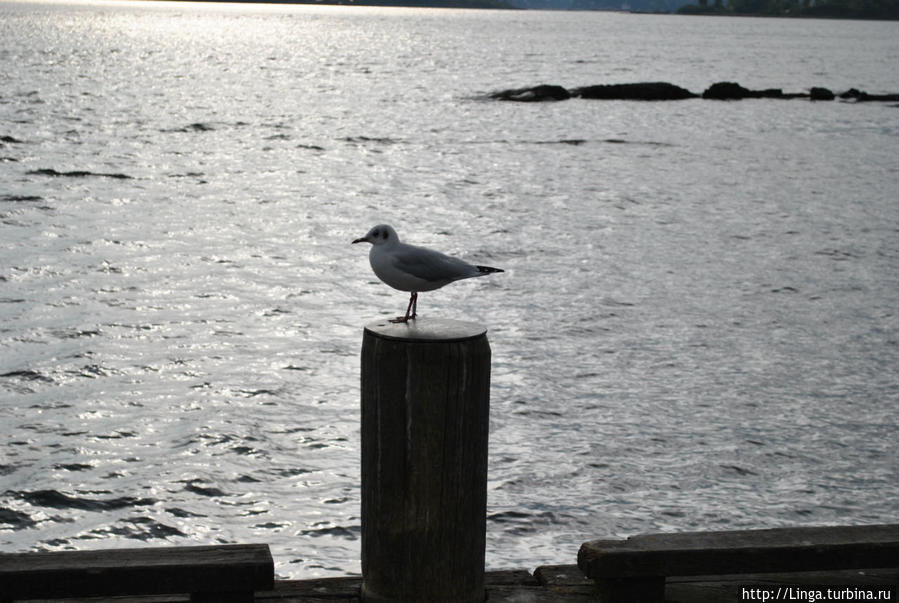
[0,544,274,603]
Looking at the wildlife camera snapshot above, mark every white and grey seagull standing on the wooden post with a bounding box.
[353,224,503,323]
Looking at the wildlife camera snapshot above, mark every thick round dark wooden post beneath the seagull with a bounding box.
[362,318,490,603]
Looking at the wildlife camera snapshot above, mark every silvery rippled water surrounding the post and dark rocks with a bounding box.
[0,2,899,577]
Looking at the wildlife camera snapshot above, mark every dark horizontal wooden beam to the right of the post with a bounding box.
[578,524,899,579]
